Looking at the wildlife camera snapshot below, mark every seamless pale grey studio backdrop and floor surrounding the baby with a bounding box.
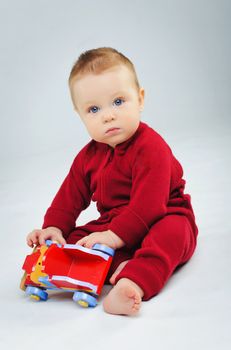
[0,0,231,349]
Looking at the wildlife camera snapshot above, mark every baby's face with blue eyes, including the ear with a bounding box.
[71,65,144,148]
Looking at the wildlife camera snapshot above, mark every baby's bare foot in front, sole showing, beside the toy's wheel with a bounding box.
[103,278,144,315]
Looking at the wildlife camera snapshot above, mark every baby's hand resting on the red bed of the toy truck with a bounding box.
[76,230,125,249]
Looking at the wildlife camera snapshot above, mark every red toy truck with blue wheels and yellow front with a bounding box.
[20,241,114,307]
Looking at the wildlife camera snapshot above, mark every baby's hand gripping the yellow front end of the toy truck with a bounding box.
[26,227,66,248]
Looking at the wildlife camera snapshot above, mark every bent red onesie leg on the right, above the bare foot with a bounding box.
[113,215,196,300]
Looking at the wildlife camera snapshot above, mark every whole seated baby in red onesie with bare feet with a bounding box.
[27,47,198,315]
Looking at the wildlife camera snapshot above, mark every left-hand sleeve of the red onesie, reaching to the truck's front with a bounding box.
[42,148,91,238]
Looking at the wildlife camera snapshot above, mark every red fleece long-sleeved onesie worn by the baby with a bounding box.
[43,122,198,300]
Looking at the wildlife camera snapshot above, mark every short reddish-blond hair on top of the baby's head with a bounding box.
[68,47,140,90]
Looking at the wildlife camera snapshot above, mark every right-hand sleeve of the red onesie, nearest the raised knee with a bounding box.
[108,139,171,248]
